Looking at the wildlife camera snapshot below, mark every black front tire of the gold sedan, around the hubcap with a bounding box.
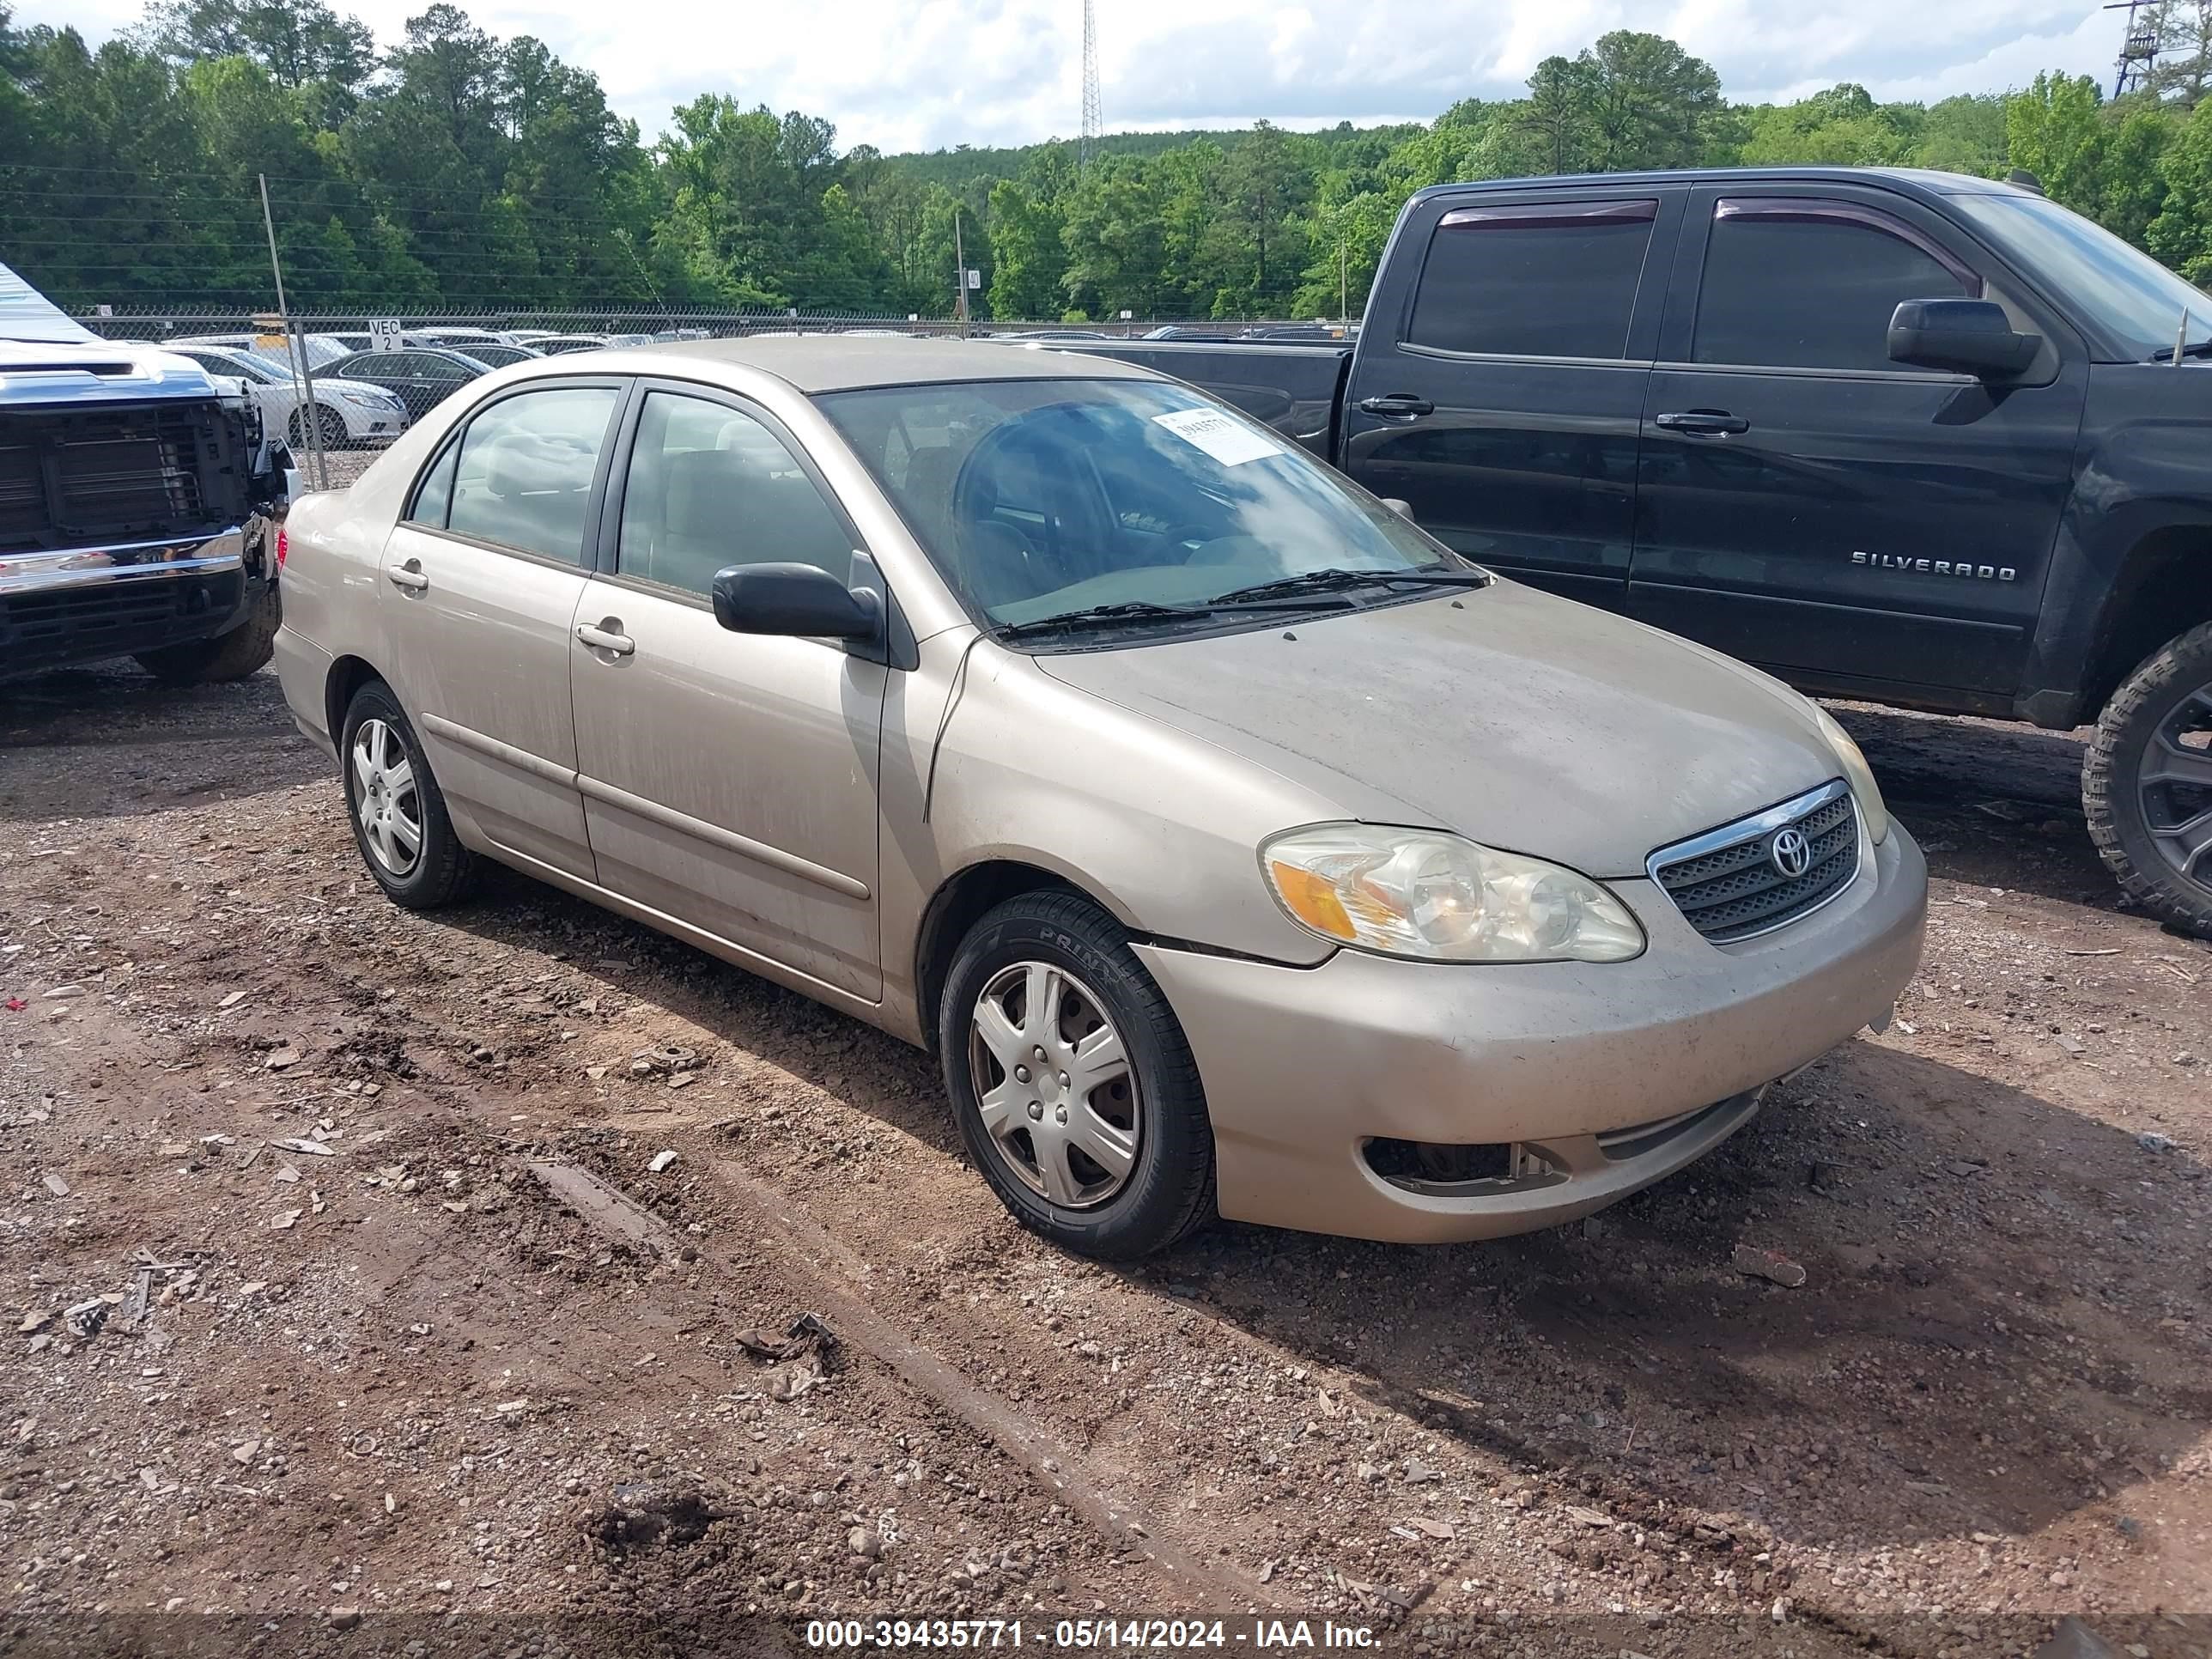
[938,891,1214,1261]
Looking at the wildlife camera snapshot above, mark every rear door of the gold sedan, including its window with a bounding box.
[376,378,622,880]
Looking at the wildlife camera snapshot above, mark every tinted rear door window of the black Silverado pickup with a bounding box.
[1407,201,1659,358]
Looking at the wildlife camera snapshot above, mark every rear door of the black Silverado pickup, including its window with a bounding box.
[1340,184,1686,608]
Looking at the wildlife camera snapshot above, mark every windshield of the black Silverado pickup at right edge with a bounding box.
[1951,192,2212,361]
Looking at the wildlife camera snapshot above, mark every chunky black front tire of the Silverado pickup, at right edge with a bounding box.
[2081,622,2212,938]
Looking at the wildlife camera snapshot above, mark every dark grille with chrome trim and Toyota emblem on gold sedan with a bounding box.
[1648,779,1858,945]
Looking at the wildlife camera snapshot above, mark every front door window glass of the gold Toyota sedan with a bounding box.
[615,392,852,595]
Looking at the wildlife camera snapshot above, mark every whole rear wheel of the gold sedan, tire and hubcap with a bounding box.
[338,679,476,909]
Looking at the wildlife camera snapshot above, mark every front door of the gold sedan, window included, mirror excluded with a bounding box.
[571,385,887,1002]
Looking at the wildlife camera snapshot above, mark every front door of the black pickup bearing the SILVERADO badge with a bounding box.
[1631,181,2086,706]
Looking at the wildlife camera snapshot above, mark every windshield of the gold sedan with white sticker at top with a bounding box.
[817,380,1471,623]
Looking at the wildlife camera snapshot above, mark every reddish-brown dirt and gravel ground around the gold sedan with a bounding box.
[0,605,2212,1659]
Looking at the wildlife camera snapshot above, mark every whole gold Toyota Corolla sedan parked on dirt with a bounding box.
[276,337,1927,1256]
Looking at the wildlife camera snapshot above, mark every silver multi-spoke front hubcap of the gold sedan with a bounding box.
[969,963,1144,1210]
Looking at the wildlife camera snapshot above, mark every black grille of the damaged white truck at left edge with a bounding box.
[0,407,216,553]
